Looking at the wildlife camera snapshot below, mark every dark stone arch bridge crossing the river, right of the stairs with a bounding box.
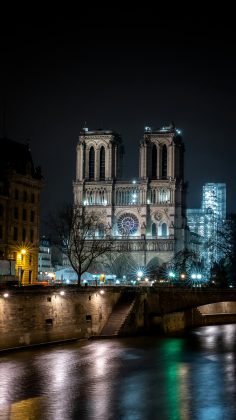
[142,288,236,333]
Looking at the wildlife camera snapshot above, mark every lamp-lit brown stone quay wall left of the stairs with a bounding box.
[0,287,120,349]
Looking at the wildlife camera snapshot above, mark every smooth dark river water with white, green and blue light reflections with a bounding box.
[0,325,236,420]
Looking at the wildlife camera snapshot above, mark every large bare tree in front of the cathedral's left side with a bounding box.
[49,205,114,286]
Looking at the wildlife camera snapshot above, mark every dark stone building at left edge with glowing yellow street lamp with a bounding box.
[0,138,43,284]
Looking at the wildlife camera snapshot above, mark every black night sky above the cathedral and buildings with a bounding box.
[0,4,236,226]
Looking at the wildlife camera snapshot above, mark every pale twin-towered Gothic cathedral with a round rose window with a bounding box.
[73,124,185,276]
